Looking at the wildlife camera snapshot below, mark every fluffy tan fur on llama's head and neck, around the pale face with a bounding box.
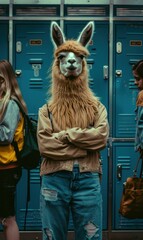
[48,41,99,130]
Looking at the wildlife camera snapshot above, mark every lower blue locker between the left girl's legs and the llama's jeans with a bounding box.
[16,168,41,231]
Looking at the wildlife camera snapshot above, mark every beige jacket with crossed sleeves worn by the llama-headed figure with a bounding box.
[37,103,109,175]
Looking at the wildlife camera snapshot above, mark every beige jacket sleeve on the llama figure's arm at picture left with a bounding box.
[37,106,87,160]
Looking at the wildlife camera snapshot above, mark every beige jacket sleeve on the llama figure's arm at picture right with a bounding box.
[58,104,109,151]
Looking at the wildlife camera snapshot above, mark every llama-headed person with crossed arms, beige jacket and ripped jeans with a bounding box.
[37,22,109,240]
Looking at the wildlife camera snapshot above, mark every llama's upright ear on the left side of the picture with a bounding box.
[51,22,65,48]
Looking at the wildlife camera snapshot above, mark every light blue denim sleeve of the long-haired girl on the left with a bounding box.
[0,100,20,145]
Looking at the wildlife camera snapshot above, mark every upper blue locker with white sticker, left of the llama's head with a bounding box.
[15,22,53,116]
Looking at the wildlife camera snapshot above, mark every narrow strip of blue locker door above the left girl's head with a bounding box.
[0,22,8,60]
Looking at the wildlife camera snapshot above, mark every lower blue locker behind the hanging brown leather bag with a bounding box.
[112,142,143,230]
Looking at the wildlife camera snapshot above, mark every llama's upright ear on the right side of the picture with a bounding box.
[77,21,94,47]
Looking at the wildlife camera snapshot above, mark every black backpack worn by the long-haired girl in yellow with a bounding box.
[12,99,40,170]
